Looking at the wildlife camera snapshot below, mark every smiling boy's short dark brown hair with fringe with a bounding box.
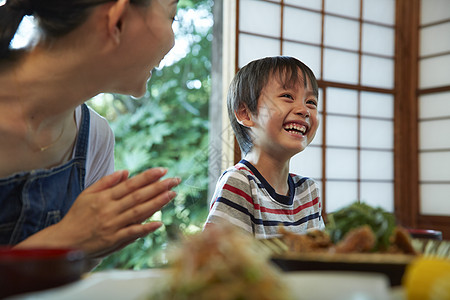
[227,56,319,154]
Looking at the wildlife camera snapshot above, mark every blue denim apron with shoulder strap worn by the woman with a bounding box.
[0,104,90,245]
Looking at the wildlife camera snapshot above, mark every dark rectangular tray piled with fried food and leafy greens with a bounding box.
[259,203,450,286]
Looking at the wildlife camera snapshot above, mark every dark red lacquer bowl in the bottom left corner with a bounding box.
[0,247,86,299]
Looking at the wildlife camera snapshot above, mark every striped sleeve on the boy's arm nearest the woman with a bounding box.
[205,170,253,234]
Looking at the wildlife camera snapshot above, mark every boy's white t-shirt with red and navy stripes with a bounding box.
[205,160,325,238]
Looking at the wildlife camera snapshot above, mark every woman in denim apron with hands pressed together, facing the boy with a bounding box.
[0,0,180,258]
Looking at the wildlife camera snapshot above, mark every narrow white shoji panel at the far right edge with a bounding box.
[418,0,450,216]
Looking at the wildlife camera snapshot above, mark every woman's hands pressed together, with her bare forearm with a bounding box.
[18,168,180,258]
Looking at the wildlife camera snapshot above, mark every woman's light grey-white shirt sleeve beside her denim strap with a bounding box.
[74,106,114,188]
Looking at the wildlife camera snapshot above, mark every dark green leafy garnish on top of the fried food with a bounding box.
[326,202,395,251]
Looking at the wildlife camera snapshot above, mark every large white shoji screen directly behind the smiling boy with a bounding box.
[236,0,395,212]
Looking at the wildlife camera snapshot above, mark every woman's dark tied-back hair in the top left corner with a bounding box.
[0,0,151,59]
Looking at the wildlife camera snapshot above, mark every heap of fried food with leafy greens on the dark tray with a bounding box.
[279,202,417,255]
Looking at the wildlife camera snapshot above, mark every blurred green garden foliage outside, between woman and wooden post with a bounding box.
[90,0,212,270]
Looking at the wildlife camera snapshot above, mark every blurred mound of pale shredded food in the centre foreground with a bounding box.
[148,224,293,300]
